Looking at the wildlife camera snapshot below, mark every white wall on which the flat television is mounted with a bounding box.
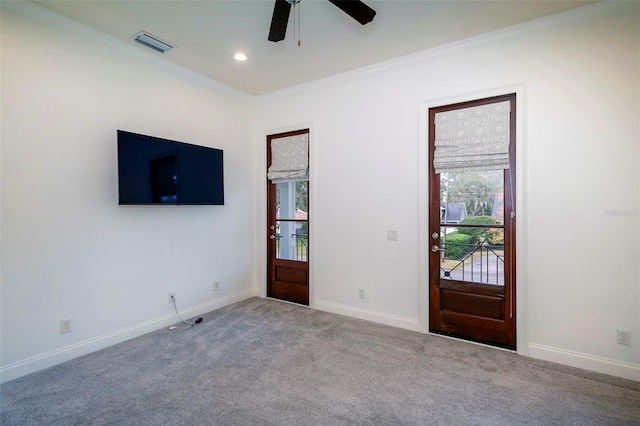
[1,5,257,380]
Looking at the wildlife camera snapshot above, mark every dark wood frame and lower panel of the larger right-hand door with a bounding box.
[428,94,516,349]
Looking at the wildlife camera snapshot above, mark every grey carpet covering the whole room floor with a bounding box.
[0,298,640,426]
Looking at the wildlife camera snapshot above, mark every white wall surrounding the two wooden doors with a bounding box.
[255,4,640,380]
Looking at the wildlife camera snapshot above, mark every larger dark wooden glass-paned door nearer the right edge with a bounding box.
[429,94,516,349]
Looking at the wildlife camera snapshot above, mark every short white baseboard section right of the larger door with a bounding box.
[529,343,640,381]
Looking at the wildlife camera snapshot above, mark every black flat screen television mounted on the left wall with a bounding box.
[118,130,224,205]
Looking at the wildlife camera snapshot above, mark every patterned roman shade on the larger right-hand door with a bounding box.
[433,101,511,173]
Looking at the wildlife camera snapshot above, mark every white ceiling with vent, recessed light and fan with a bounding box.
[36,0,592,95]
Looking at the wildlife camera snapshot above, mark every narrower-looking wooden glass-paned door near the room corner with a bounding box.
[267,129,309,305]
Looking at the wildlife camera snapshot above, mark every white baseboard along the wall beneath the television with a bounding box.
[0,288,260,383]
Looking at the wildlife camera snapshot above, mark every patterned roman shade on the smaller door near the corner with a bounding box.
[267,133,309,183]
